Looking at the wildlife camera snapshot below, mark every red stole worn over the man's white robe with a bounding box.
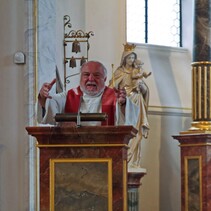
[65,86,116,125]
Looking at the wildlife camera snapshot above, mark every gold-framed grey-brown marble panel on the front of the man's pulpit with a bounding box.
[49,158,113,211]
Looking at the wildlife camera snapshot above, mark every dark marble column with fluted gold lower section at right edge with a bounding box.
[190,0,211,133]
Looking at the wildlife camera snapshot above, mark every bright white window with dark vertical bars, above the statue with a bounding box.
[126,0,182,47]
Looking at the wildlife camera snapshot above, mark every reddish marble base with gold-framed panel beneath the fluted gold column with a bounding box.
[173,134,211,211]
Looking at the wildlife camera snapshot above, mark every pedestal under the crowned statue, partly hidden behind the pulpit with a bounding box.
[128,168,146,211]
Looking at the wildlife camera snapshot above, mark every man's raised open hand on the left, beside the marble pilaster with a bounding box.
[38,79,56,108]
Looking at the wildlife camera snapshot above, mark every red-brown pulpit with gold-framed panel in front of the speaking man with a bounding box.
[26,125,137,211]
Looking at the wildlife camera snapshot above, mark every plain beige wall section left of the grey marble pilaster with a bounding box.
[0,0,29,211]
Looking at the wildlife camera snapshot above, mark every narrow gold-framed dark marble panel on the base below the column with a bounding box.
[184,156,202,211]
